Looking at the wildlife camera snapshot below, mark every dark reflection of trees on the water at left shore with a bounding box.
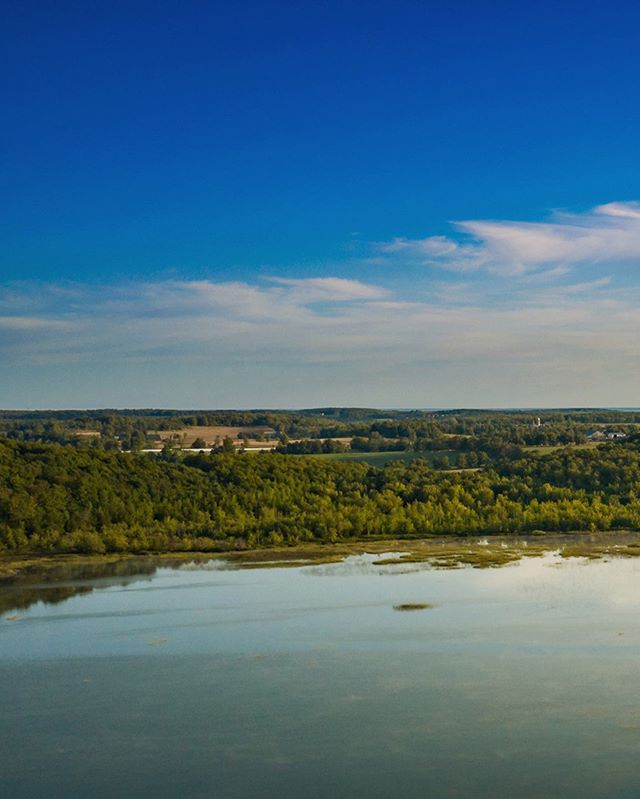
[0,558,166,613]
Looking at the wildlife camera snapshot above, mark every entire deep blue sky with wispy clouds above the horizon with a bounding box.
[0,0,640,408]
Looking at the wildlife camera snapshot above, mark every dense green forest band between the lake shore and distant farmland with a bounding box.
[0,436,640,553]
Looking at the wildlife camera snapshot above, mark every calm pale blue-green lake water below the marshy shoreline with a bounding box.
[0,555,640,799]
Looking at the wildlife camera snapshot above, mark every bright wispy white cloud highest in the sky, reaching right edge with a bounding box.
[377,202,640,277]
